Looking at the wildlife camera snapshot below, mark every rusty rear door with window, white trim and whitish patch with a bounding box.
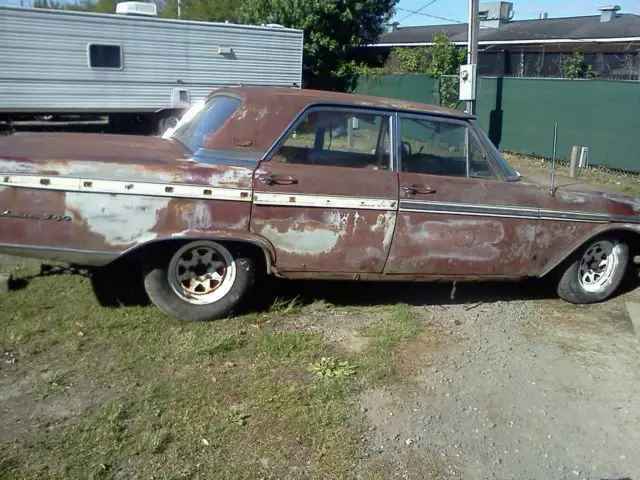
[250,107,398,274]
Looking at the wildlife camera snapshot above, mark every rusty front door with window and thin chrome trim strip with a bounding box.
[385,115,538,277]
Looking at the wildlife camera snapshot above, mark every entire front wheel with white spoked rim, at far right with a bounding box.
[558,238,629,304]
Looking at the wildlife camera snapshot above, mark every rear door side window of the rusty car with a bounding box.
[273,109,391,170]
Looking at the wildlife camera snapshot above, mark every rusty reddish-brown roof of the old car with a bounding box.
[214,87,472,119]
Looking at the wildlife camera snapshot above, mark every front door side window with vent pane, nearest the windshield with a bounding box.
[400,118,496,178]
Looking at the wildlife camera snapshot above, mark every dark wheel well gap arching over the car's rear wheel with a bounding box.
[112,238,271,273]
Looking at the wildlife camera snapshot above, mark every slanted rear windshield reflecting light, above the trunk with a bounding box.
[168,95,242,153]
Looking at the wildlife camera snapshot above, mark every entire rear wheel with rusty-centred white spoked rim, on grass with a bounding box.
[144,240,255,322]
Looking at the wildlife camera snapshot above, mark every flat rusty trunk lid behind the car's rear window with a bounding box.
[0,132,189,165]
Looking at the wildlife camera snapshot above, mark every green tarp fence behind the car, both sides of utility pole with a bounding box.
[356,74,640,172]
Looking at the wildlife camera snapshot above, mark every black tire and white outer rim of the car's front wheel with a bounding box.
[557,237,629,304]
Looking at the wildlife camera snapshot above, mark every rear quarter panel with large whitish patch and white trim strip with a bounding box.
[0,159,253,264]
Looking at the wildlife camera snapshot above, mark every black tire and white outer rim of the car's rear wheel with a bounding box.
[143,240,256,322]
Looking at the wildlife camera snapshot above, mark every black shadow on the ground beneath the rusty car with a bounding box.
[10,264,640,314]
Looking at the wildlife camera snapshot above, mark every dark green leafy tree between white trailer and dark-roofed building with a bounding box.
[239,0,399,90]
